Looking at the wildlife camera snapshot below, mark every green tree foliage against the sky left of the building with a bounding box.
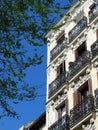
[0,0,73,117]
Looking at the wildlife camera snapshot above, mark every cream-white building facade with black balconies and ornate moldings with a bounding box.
[46,0,98,130]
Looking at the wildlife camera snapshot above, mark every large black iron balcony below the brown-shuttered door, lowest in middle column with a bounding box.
[70,95,95,127]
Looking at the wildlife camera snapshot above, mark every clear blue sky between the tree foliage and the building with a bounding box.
[0,0,76,130]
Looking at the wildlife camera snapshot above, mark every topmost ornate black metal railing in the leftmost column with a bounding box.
[50,38,66,61]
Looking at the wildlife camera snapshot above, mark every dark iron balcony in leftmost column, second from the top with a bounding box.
[49,72,66,97]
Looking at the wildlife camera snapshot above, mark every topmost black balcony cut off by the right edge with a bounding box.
[89,4,98,23]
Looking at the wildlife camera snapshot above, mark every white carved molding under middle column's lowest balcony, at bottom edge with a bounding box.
[82,118,96,130]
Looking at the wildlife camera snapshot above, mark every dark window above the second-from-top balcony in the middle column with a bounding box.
[75,42,87,60]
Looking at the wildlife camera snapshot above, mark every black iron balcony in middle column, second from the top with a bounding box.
[68,51,91,80]
